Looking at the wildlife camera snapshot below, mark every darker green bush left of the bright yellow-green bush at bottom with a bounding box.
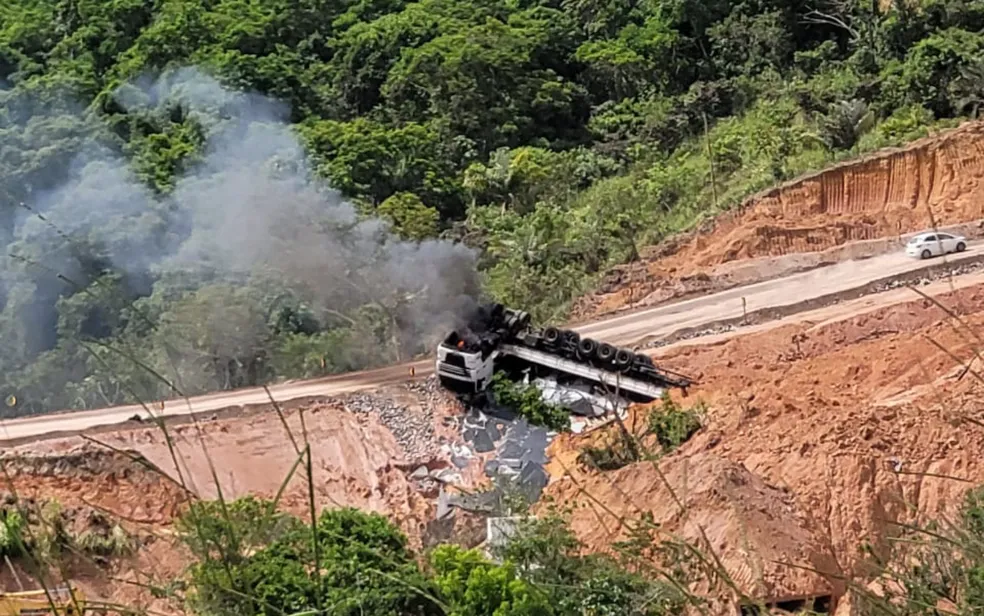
[180,500,441,616]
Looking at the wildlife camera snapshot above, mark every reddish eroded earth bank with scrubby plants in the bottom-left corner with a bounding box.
[0,442,193,613]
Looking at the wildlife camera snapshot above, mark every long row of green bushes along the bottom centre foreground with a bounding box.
[173,500,686,616]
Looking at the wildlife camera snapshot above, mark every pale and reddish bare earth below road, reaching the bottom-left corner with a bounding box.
[0,386,480,614]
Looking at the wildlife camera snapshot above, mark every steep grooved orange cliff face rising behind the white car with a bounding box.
[681,122,984,266]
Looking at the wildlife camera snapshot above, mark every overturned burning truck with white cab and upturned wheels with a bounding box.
[437,304,693,402]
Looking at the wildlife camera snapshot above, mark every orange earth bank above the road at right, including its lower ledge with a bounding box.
[572,121,984,320]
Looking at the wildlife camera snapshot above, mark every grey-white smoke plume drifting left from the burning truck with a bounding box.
[0,63,479,400]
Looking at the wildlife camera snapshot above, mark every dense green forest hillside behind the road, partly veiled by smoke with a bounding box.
[0,0,984,414]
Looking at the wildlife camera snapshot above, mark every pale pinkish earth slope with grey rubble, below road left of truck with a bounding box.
[23,383,468,542]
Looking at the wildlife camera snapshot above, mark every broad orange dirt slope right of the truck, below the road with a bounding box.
[659,286,984,572]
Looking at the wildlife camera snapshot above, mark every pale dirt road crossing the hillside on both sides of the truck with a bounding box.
[0,245,981,441]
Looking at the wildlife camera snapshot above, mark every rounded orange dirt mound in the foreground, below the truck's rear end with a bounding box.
[550,452,840,600]
